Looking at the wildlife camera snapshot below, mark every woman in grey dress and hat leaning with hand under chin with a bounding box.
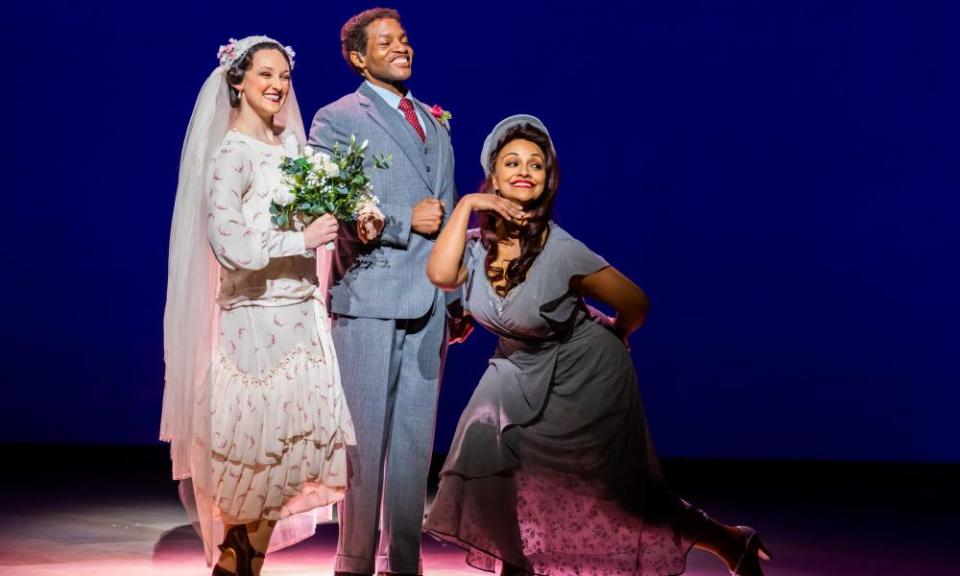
[425,115,769,576]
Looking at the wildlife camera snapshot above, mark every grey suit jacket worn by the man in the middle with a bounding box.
[308,83,458,319]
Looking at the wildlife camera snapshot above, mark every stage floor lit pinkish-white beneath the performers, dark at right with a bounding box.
[0,446,960,576]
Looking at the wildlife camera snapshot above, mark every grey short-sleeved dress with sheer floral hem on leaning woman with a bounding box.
[425,223,703,576]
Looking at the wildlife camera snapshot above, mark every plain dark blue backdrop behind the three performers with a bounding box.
[0,0,960,461]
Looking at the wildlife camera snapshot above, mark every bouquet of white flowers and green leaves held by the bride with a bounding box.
[270,135,392,250]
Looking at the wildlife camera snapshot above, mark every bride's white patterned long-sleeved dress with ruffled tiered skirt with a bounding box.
[203,131,355,522]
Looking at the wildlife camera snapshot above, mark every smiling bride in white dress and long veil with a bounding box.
[161,36,382,576]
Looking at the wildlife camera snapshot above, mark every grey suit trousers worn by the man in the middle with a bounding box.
[333,291,446,574]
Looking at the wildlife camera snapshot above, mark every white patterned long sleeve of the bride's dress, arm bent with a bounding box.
[207,143,306,270]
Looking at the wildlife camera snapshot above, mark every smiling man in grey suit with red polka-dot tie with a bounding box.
[309,8,464,575]
